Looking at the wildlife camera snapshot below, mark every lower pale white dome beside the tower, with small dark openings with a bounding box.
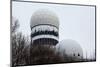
[56,39,83,58]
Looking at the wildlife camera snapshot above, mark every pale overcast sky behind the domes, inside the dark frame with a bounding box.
[12,2,95,57]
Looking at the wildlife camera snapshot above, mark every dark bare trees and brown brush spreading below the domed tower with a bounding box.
[11,18,95,67]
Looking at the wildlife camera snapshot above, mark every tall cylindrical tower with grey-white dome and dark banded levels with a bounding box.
[30,9,59,45]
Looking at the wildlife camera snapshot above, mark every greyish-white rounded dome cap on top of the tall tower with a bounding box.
[30,9,59,28]
